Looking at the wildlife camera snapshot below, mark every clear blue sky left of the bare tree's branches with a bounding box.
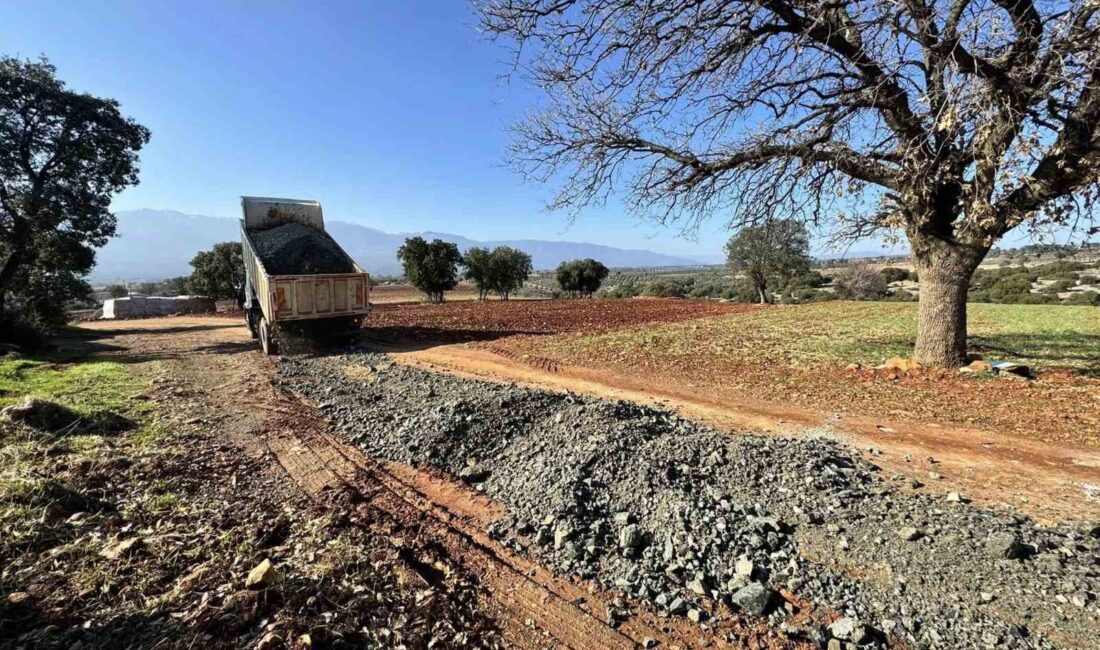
[0,0,1047,256]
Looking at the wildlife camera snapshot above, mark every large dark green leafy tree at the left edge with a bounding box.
[0,57,150,326]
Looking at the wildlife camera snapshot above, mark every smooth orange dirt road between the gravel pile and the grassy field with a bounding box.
[387,341,1100,521]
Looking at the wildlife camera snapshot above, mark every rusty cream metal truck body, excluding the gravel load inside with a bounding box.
[241,197,371,354]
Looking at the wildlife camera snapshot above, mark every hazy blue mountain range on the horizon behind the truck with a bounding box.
[91,210,704,282]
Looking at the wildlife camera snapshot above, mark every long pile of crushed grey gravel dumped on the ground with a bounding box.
[281,353,1100,648]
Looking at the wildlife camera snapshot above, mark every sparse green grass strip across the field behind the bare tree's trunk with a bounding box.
[546,301,1100,371]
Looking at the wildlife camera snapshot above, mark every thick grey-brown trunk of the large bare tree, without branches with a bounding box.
[913,242,987,367]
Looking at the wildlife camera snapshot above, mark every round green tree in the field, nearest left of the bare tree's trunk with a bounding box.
[726,219,810,304]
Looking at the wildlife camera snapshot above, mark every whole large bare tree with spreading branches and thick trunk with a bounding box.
[475,0,1100,365]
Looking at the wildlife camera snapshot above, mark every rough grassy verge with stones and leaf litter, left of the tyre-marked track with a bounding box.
[0,347,495,650]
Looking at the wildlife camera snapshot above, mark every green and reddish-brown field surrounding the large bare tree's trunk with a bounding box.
[495,302,1100,447]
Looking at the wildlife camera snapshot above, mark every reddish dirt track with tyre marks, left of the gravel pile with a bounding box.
[75,318,800,648]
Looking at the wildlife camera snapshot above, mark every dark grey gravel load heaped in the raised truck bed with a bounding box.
[249,221,355,275]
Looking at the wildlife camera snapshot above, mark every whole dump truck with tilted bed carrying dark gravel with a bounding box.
[241,197,371,354]
